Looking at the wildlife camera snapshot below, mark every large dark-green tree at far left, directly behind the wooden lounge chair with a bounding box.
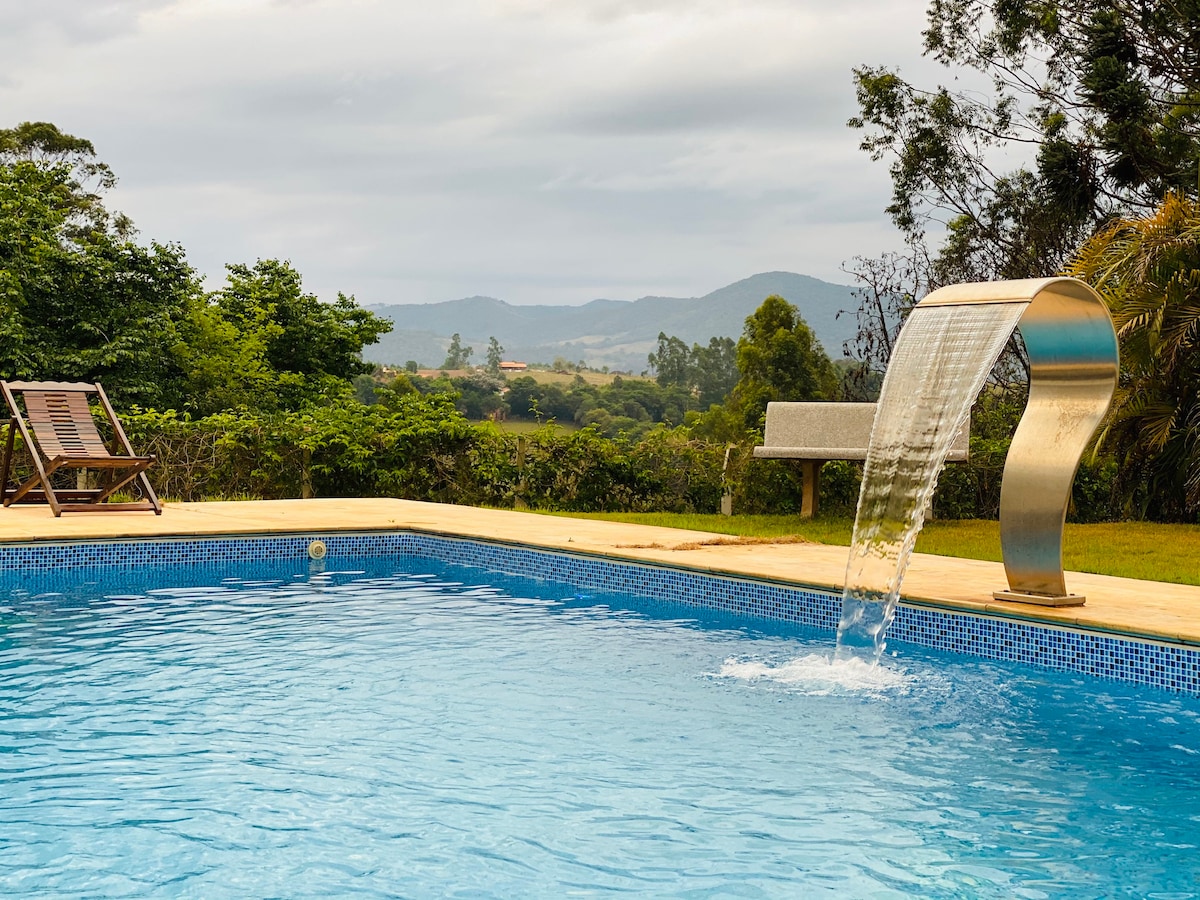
[0,156,200,404]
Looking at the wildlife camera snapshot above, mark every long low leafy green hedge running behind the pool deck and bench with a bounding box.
[114,395,1121,521]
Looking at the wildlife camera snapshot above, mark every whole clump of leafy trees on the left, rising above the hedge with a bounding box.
[0,122,391,415]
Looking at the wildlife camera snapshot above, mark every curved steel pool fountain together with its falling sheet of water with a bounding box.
[838,278,1117,658]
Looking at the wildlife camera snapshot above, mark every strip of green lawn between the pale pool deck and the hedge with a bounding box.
[556,512,1200,586]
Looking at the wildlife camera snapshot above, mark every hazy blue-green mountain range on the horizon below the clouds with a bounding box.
[362,272,858,373]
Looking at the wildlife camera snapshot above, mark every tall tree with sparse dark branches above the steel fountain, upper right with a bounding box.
[851,0,1200,287]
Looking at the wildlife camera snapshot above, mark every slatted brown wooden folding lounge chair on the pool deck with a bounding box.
[0,380,162,516]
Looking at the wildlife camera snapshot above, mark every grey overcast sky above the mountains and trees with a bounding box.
[0,0,937,304]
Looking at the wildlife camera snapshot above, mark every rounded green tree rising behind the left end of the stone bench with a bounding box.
[730,294,838,431]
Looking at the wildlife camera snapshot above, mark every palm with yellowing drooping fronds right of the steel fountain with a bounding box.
[1069,194,1200,521]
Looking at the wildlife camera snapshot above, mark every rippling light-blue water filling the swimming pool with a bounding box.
[0,558,1200,898]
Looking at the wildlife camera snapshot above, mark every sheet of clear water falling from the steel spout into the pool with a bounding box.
[836,302,1028,661]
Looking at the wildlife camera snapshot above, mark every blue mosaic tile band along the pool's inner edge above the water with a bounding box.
[0,532,1200,694]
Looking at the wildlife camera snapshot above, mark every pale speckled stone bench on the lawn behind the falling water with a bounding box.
[754,402,971,518]
